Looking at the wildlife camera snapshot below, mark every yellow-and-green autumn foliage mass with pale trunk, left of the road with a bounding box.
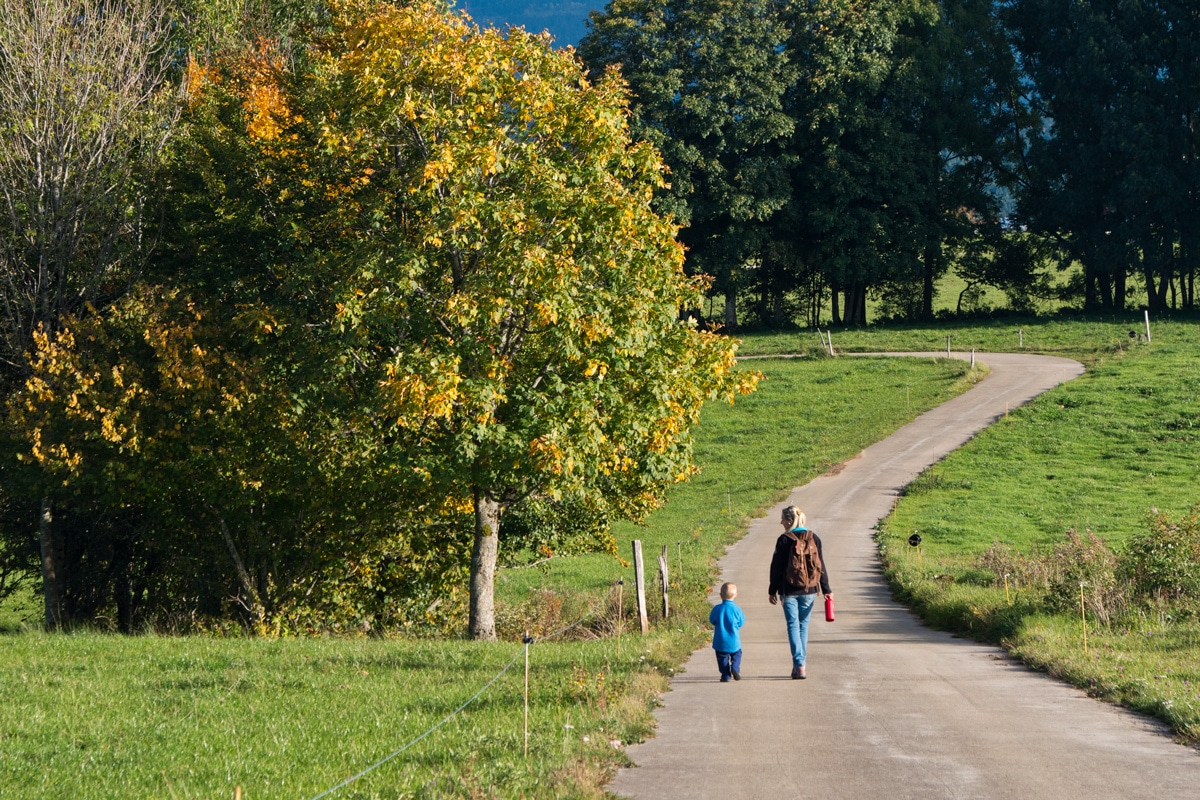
[9,2,754,638]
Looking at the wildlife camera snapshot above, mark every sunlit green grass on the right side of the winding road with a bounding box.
[873,320,1200,742]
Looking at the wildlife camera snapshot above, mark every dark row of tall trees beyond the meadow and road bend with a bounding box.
[580,0,1200,329]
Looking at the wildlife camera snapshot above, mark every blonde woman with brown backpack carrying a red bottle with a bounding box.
[769,506,833,680]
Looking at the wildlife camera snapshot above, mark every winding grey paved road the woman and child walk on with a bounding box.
[610,354,1200,800]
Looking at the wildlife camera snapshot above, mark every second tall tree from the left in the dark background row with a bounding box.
[763,0,930,324]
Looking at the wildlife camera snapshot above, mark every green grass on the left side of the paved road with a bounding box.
[0,359,977,800]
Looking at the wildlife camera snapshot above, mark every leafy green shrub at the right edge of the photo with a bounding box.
[1121,505,1200,601]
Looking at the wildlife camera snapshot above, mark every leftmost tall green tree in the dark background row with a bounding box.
[580,0,794,330]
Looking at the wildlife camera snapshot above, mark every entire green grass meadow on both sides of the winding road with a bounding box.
[0,315,1200,800]
